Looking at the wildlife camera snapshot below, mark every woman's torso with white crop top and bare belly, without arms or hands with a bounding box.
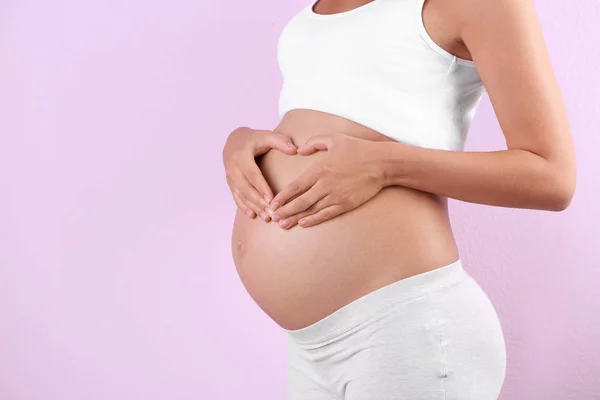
[231,0,484,329]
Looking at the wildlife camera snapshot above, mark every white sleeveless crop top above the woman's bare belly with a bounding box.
[277,0,485,150]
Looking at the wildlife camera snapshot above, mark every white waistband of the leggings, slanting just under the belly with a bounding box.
[283,259,470,345]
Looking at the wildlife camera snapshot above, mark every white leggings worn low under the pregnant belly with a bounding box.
[284,260,506,400]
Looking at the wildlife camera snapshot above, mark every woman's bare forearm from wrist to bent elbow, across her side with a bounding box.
[376,141,574,211]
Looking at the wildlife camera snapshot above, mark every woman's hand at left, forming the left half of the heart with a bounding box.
[223,127,297,222]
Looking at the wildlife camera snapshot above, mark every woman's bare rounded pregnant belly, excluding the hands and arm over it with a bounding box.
[231,109,459,330]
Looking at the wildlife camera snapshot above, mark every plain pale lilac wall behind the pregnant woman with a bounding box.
[0,0,600,400]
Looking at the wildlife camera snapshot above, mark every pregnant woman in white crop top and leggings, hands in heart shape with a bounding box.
[223,0,576,400]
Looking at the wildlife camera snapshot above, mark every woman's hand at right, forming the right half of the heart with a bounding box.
[265,133,385,229]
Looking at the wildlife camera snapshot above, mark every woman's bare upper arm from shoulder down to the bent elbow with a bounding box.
[453,0,575,179]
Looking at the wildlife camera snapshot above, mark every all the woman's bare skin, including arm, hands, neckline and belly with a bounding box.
[223,0,575,329]
